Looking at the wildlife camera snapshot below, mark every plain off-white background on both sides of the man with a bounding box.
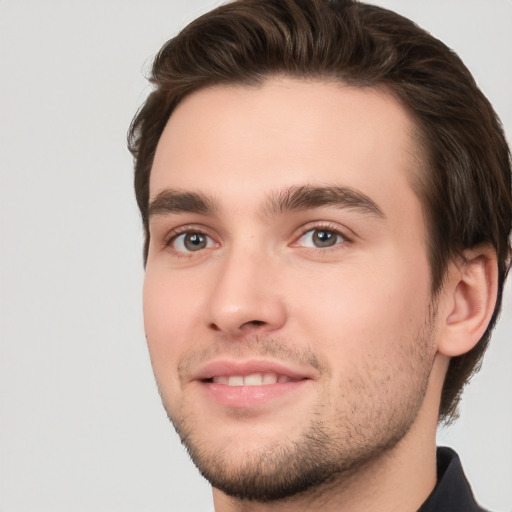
[0,0,512,512]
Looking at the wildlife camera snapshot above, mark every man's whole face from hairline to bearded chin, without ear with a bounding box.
[144,79,436,501]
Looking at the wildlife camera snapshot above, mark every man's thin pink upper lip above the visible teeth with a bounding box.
[192,359,315,380]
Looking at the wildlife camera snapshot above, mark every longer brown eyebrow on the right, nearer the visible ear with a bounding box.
[264,185,386,218]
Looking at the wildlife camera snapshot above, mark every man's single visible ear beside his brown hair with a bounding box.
[438,246,498,357]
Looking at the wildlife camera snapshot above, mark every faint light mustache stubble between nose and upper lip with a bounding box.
[178,335,326,379]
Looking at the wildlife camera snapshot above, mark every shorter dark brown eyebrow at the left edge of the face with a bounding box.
[148,189,218,218]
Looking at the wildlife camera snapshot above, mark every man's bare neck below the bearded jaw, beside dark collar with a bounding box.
[213,357,447,512]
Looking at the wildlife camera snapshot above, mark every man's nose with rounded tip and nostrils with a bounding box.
[207,249,287,337]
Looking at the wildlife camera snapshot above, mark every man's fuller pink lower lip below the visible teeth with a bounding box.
[201,379,309,409]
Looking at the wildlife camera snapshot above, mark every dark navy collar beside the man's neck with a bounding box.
[418,447,486,512]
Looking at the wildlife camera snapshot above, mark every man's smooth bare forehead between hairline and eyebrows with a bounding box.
[150,78,422,220]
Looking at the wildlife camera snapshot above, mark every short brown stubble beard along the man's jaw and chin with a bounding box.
[159,318,434,503]
